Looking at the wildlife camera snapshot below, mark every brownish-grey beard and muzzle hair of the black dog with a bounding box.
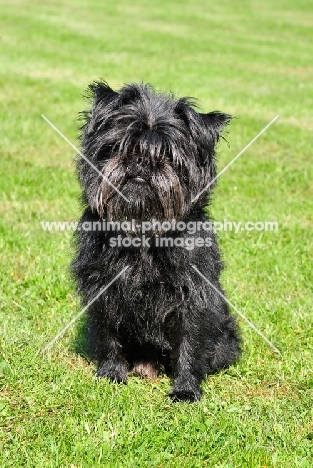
[93,158,185,229]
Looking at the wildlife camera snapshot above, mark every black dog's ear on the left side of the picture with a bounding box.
[82,81,119,134]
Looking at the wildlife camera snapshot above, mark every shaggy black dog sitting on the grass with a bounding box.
[72,82,240,401]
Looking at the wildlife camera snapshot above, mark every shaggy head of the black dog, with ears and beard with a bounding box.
[78,82,231,221]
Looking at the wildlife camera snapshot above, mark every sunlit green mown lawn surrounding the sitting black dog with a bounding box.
[0,0,313,468]
